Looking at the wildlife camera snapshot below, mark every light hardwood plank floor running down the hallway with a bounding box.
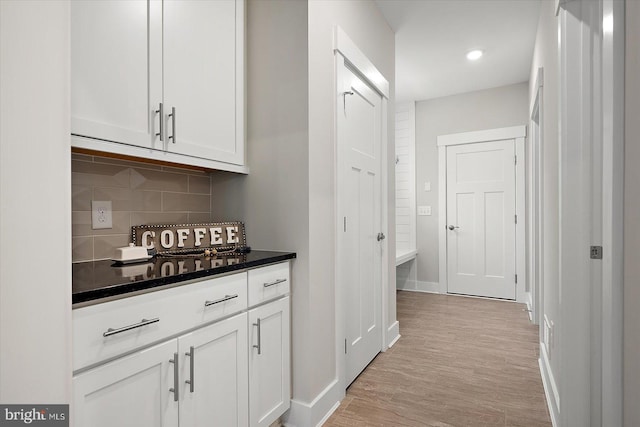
[324,291,551,427]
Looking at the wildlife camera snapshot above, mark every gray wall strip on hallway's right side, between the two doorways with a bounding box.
[529,2,560,402]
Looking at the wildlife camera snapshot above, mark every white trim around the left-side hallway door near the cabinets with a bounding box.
[333,25,390,400]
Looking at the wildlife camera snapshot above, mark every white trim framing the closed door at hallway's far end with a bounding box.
[437,125,527,303]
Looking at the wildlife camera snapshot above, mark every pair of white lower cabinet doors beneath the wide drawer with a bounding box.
[73,313,249,427]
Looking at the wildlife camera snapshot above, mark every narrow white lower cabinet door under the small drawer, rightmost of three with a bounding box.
[249,297,291,427]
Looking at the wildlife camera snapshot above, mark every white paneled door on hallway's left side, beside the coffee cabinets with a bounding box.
[337,65,382,384]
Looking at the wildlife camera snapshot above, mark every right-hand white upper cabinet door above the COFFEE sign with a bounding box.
[163,0,244,165]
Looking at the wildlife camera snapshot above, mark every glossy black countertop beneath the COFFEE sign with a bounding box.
[72,251,296,306]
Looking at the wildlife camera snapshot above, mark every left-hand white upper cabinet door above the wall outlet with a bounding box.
[71,0,163,149]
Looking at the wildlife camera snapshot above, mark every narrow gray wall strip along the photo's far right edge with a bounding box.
[623,1,640,427]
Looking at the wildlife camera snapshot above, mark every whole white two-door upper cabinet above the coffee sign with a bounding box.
[71,0,246,172]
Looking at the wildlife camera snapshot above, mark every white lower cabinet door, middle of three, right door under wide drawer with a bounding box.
[178,313,249,427]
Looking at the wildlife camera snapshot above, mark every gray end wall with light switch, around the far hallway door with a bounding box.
[416,83,529,288]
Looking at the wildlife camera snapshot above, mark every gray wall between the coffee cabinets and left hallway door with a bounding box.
[211,0,396,425]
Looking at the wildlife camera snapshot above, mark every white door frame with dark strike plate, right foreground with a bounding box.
[550,0,625,426]
